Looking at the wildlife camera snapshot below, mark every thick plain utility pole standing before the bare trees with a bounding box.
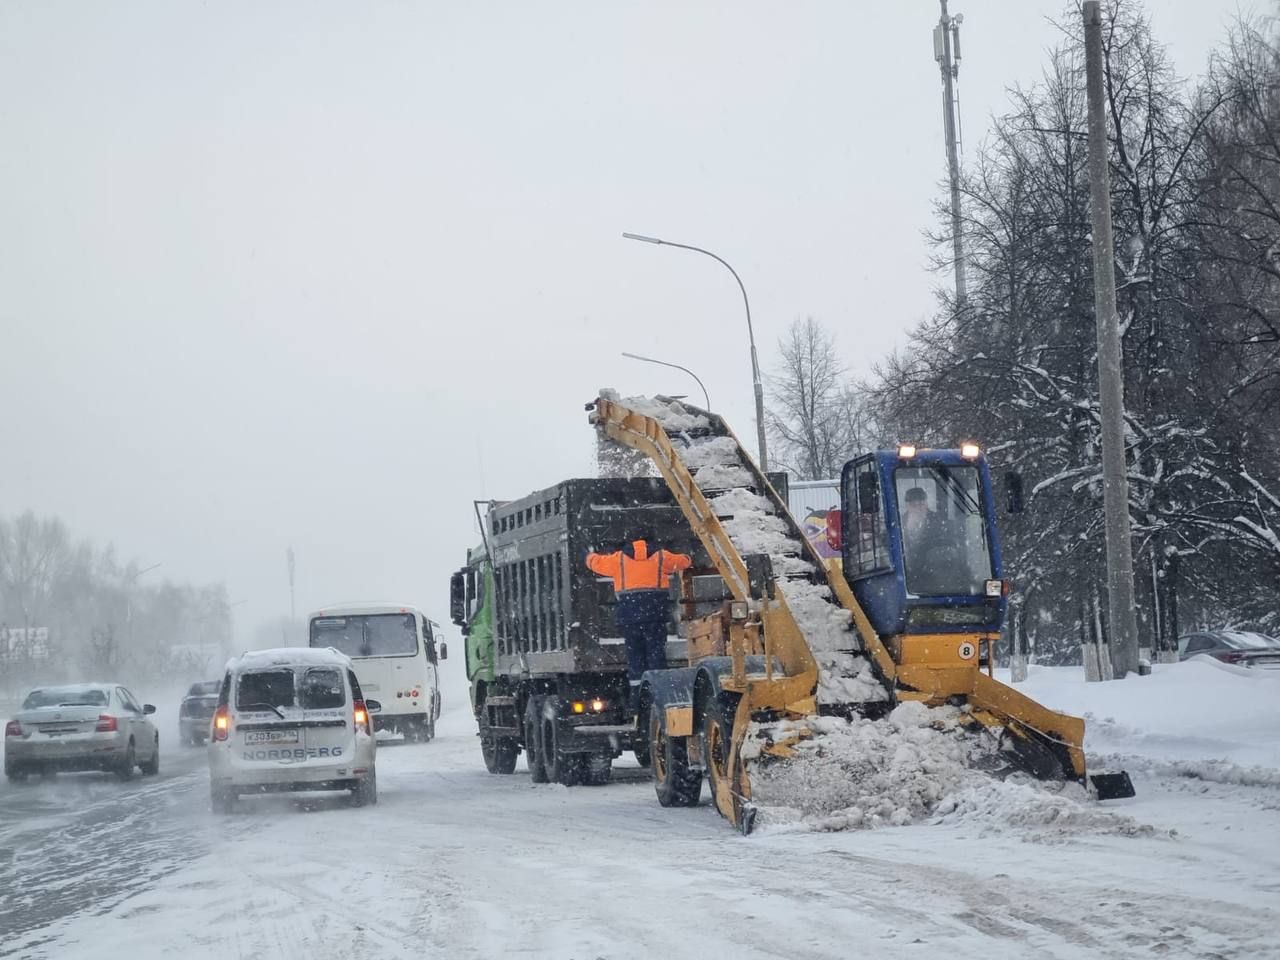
[1084,0,1138,678]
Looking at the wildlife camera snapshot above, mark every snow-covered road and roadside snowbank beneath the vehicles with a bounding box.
[0,662,1280,960]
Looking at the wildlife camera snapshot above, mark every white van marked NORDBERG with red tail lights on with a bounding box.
[209,646,380,813]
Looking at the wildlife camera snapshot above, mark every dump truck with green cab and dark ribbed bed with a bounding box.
[449,477,709,785]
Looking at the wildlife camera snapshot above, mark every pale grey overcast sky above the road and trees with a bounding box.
[0,0,1251,644]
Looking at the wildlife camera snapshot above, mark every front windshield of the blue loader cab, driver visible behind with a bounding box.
[893,466,992,596]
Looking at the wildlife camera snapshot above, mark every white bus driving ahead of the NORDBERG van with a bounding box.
[308,603,448,740]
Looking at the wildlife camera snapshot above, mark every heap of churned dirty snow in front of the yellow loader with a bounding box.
[742,701,995,829]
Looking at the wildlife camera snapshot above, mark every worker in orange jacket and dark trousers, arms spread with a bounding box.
[586,539,691,689]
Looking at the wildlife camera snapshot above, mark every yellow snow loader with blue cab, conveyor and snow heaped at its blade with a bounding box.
[588,392,1134,833]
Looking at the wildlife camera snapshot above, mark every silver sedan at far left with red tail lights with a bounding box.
[4,684,160,781]
